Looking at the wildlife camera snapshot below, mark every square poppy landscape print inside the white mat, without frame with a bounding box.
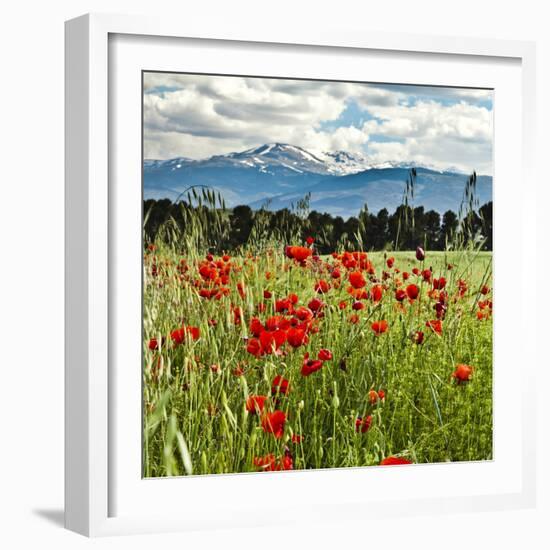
[142,71,494,478]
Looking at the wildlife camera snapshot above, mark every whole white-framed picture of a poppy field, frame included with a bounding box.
[66,15,536,536]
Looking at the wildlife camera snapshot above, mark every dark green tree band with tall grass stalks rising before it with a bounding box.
[144,168,493,254]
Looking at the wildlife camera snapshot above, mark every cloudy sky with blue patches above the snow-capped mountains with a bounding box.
[143,73,493,175]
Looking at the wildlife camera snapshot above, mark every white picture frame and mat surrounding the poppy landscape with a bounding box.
[65,15,536,536]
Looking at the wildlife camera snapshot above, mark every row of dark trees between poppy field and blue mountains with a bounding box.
[144,199,493,254]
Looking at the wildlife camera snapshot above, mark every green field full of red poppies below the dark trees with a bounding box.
[143,244,493,477]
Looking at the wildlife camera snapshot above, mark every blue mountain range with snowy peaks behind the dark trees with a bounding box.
[143,143,493,218]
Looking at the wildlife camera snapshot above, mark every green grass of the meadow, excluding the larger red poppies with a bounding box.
[143,244,493,477]
